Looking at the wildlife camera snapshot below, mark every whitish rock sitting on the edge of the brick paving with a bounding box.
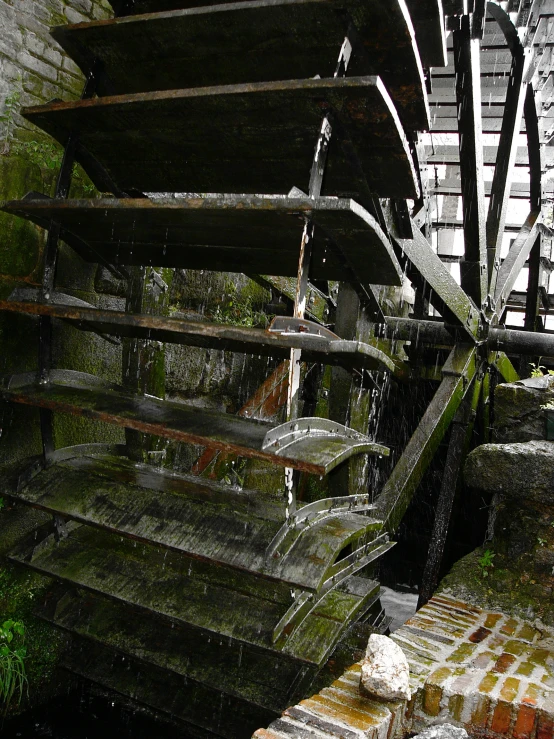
[360,634,412,701]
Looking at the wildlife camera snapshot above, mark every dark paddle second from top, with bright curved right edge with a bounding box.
[23,77,417,197]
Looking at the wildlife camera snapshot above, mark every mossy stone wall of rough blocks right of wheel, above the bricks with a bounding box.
[441,375,554,626]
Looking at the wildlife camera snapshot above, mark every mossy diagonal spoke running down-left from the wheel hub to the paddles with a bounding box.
[375,346,476,531]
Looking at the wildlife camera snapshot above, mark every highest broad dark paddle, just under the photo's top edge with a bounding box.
[53,0,426,130]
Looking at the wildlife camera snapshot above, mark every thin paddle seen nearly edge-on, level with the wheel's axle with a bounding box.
[0,300,394,371]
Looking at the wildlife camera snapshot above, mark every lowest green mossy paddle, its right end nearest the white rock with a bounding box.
[10,526,375,666]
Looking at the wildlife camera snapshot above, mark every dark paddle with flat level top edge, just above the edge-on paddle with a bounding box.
[3,195,402,285]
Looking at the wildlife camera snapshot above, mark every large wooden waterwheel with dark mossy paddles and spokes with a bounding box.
[0,0,554,738]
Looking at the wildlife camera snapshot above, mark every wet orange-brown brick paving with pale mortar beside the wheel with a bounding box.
[254,594,554,739]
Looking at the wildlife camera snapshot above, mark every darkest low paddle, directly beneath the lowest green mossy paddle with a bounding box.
[40,586,304,711]
